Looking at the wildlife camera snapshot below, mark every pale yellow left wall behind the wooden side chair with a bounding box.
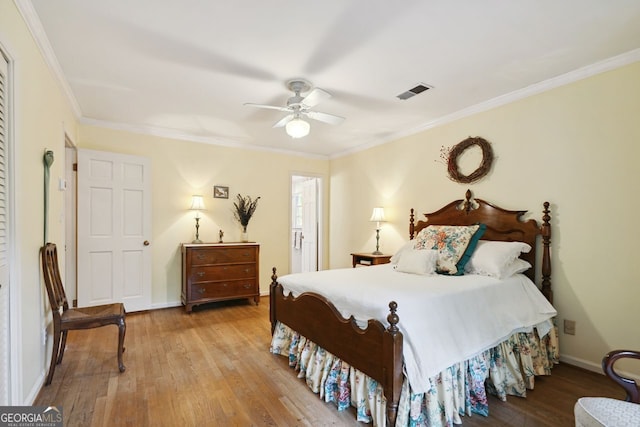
[0,1,77,404]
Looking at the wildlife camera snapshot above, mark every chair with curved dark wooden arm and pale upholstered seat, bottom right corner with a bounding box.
[574,350,640,427]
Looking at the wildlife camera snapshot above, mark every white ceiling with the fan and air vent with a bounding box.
[23,0,640,156]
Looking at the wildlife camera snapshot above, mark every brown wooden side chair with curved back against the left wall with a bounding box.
[40,243,127,385]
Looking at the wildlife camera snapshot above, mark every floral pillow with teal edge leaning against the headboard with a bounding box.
[414,224,487,276]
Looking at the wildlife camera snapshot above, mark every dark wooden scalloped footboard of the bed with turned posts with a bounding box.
[269,267,403,426]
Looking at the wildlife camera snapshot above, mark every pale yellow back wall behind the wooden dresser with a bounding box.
[78,126,329,307]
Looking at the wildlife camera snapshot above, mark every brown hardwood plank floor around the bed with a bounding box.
[34,297,623,427]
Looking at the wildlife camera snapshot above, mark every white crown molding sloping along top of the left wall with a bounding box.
[13,0,82,119]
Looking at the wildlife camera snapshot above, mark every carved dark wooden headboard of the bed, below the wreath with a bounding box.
[409,190,553,303]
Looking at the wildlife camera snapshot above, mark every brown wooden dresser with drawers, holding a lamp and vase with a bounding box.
[182,243,260,313]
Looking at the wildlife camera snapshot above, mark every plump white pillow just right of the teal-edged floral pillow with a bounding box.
[465,240,531,279]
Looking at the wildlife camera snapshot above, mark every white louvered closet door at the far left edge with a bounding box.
[0,51,10,406]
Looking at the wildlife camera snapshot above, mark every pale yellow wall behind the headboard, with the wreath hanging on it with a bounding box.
[330,63,640,373]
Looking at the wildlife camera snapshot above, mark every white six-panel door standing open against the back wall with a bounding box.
[78,150,151,312]
